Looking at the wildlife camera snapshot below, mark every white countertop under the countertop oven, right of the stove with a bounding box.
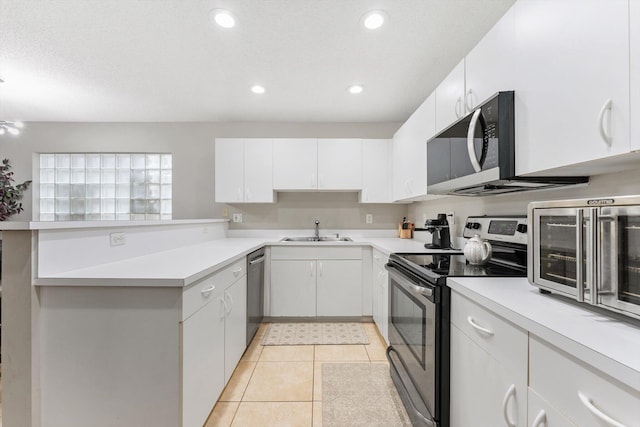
[447,277,640,391]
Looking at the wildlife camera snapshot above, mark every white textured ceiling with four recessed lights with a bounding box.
[0,0,515,122]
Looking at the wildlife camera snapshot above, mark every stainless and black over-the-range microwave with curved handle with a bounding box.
[427,91,589,196]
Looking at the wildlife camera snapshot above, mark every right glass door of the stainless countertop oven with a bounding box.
[598,206,640,317]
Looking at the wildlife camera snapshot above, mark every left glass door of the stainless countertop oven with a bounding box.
[532,208,597,303]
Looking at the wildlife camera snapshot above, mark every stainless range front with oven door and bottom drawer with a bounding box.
[387,264,440,427]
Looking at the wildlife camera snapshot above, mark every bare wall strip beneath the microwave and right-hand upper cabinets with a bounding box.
[408,165,640,241]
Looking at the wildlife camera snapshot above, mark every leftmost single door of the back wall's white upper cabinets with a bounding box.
[214,138,244,203]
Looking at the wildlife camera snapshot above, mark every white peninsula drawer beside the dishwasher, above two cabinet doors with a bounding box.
[182,258,247,320]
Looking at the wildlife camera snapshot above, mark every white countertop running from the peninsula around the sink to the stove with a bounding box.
[35,236,436,287]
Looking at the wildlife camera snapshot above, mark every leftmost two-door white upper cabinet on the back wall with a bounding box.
[215,138,274,203]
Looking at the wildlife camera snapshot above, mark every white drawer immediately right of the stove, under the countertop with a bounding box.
[451,292,529,384]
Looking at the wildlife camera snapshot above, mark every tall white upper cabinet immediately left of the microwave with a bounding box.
[393,92,436,201]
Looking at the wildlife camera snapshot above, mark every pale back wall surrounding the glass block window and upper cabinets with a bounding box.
[0,122,406,229]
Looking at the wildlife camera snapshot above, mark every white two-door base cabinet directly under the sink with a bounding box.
[270,246,363,317]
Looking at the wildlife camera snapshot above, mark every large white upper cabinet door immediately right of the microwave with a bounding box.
[513,0,630,174]
